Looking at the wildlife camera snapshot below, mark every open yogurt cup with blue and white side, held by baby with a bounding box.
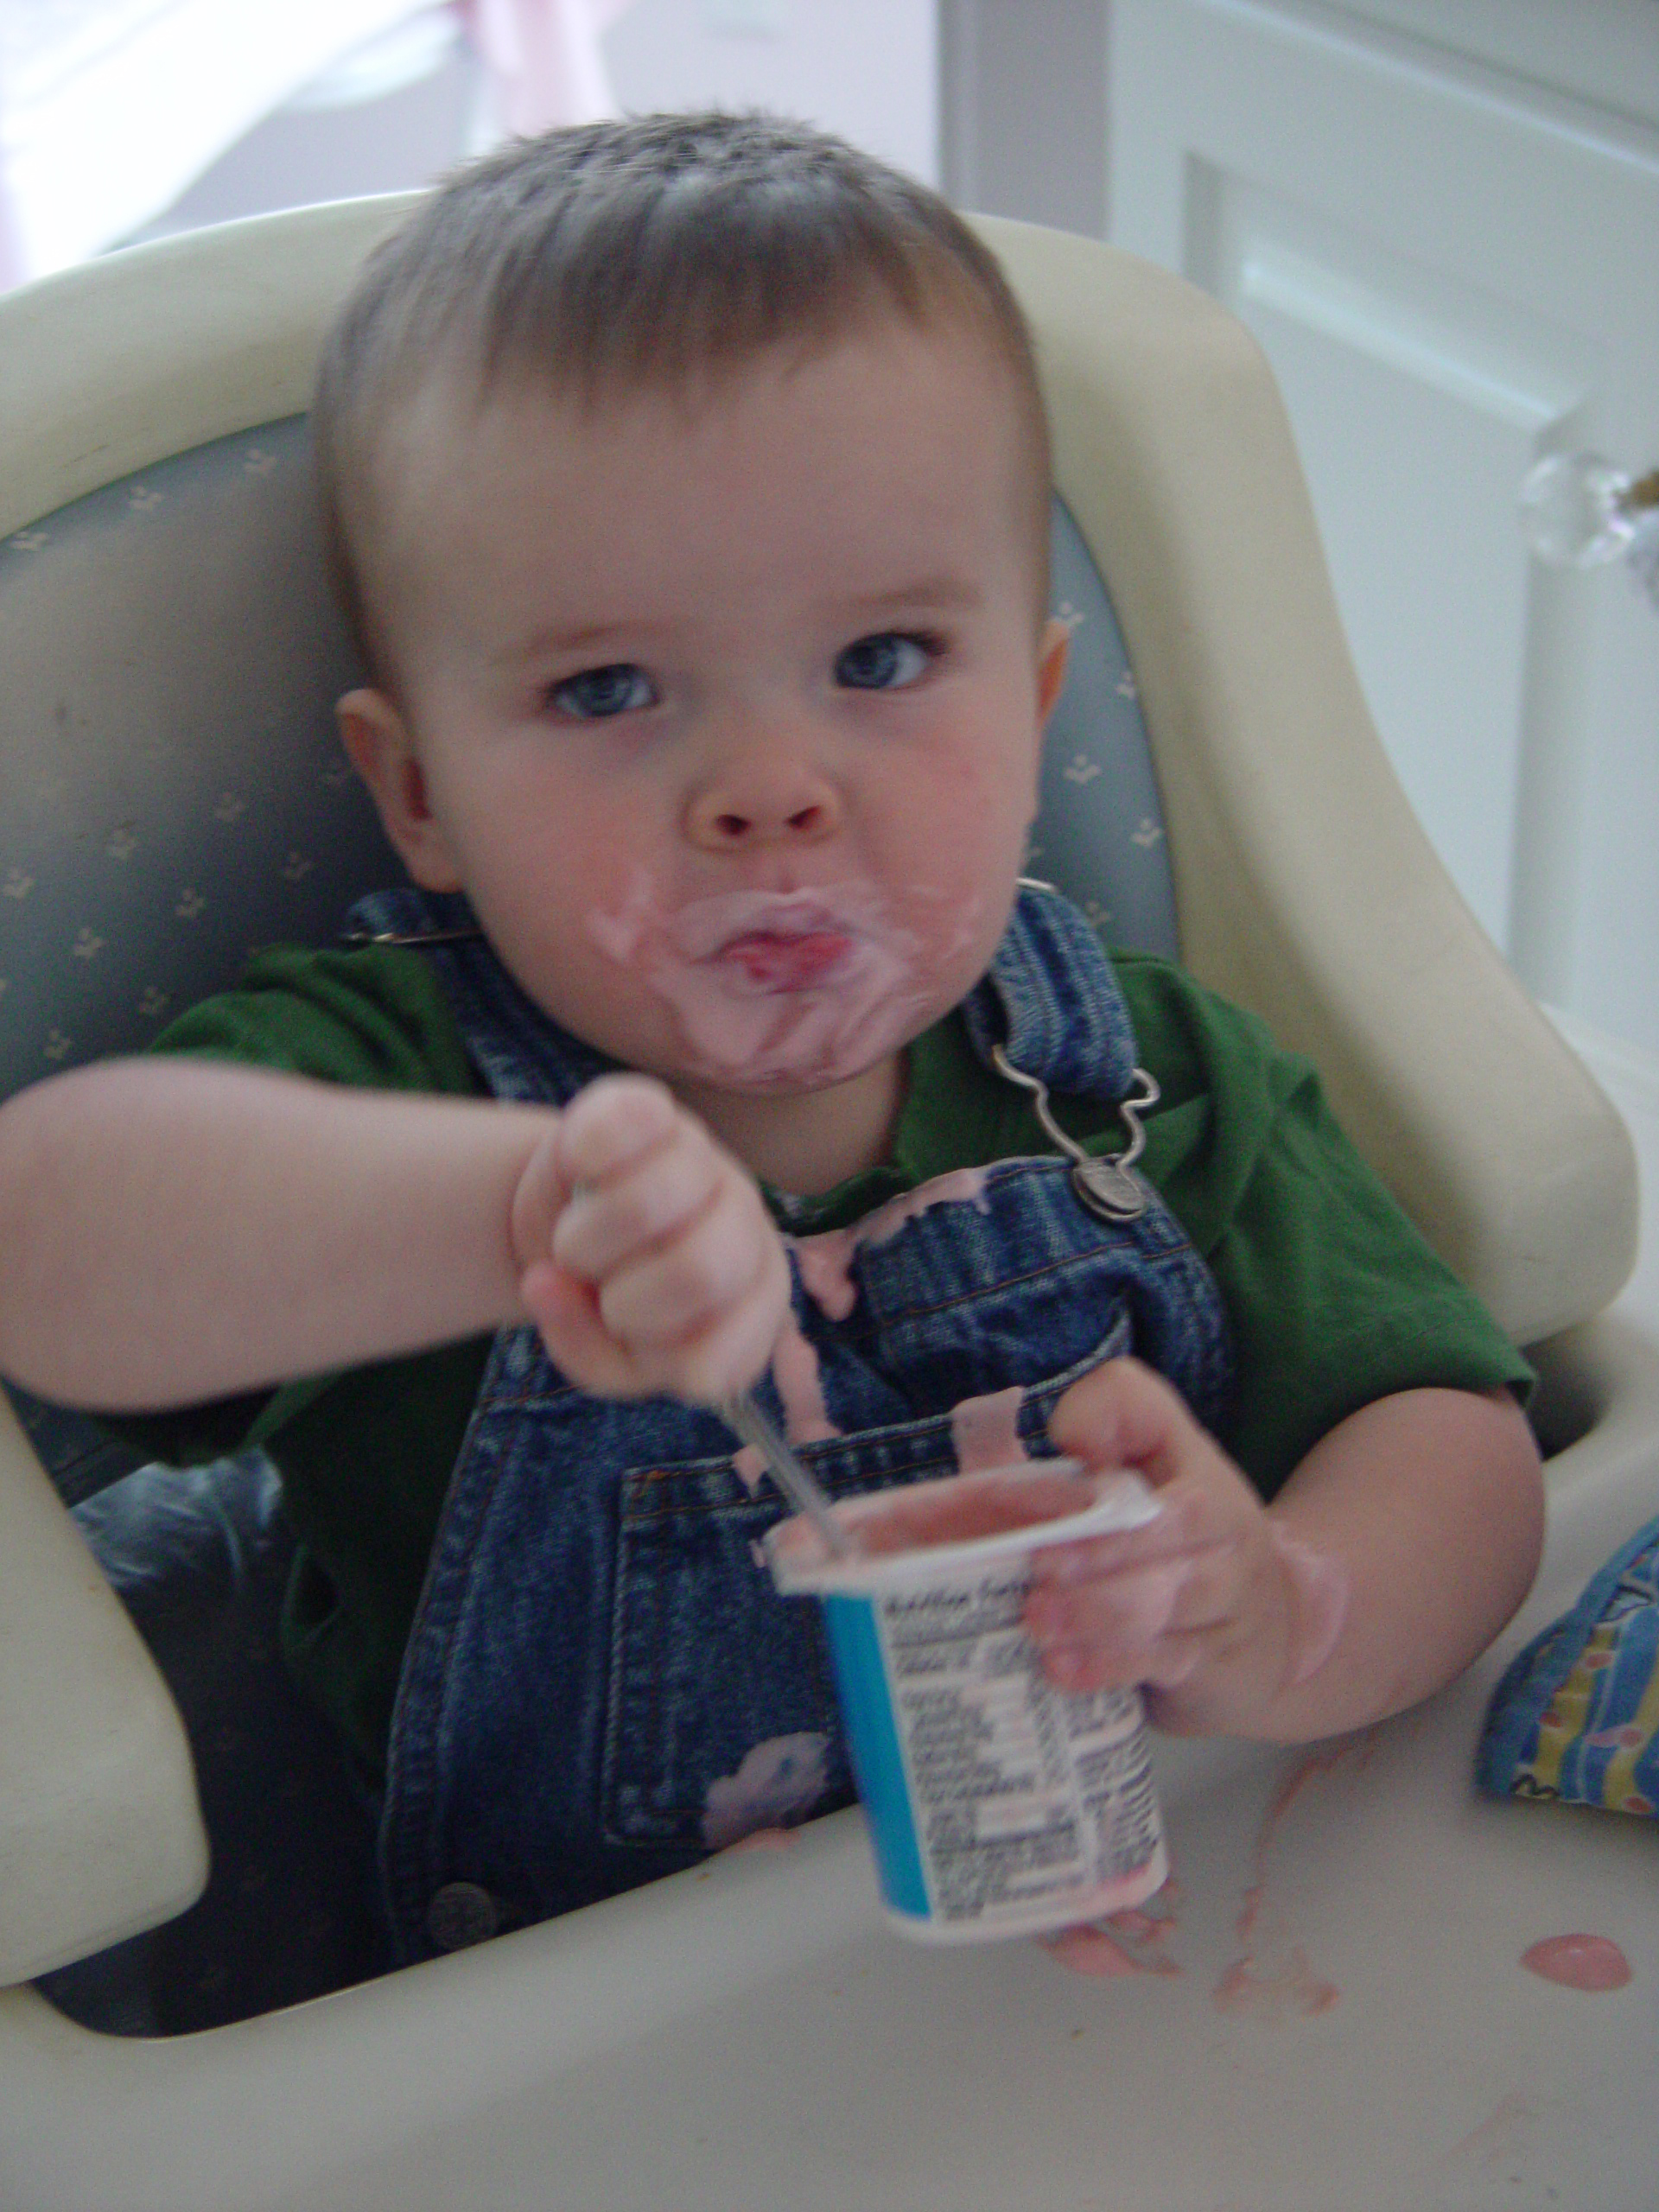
[766,1460,1168,1942]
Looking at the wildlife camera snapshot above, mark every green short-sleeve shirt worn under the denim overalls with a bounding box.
[124,947,1531,1772]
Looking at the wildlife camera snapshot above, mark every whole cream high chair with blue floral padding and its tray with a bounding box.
[0,199,1659,2212]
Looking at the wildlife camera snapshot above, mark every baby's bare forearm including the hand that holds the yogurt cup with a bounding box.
[1028,1360,1544,1743]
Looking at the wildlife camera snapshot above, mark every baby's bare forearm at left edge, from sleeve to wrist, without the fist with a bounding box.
[0,1059,557,1411]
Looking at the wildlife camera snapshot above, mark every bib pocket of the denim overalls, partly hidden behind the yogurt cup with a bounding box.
[601,1316,1128,1849]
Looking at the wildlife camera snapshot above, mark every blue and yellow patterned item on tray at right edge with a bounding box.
[1476,1522,1659,1814]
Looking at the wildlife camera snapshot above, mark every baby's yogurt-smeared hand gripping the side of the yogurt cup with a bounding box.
[1024,1360,1347,1737]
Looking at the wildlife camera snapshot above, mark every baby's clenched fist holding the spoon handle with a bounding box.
[513,1075,790,1402]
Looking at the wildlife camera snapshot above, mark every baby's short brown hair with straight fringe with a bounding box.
[312,113,1048,666]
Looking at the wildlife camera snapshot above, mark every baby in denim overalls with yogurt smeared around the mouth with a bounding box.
[0,118,1541,1958]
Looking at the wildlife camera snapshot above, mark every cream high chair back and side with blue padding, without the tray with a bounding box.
[0,199,1635,1982]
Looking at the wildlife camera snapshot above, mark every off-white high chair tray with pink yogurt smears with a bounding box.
[0,1323,1659,2212]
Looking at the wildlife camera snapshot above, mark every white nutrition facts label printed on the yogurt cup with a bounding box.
[876,1568,1161,1923]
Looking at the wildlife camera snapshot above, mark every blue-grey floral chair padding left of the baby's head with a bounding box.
[0,420,398,1095]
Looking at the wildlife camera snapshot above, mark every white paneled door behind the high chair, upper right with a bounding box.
[1109,0,1659,1051]
